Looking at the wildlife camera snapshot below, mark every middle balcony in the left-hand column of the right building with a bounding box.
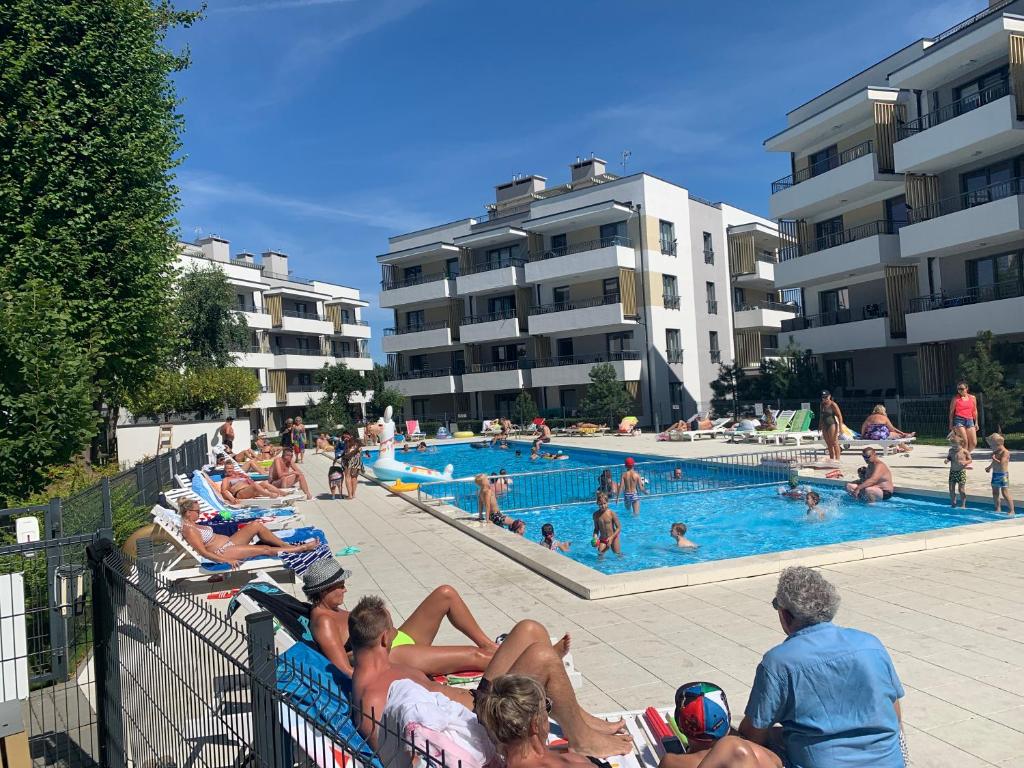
[775,220,900,288]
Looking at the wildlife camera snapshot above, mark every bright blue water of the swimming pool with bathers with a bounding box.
[397,445,1005,573]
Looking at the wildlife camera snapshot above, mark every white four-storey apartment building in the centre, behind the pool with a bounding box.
[377,158,774,425]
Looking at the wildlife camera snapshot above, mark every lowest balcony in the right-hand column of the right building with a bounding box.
[906,279,1024,344]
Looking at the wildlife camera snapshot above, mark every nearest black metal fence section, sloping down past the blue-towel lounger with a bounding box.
[90,543,461,768]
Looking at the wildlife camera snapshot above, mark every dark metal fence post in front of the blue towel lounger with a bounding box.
[246,610,287,768]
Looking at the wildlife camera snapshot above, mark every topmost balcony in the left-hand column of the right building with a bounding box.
[769,141,903,219]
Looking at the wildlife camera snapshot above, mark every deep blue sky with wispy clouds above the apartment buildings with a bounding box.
[170,0,986,357]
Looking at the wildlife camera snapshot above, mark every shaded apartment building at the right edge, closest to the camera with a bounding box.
[765,0,1024,396]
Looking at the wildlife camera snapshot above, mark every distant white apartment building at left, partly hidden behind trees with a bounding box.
[178,236,373,432]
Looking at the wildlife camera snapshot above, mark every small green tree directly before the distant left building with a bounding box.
[174,264,249,370]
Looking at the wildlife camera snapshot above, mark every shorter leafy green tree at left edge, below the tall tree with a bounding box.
[0,279,99,507]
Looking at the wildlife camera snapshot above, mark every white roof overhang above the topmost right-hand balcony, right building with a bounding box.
[889,13,1024,90]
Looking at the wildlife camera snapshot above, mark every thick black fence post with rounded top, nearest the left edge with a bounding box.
[86,539,125,766]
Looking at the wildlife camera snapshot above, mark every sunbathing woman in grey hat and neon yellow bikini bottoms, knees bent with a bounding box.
[302,557,498,675]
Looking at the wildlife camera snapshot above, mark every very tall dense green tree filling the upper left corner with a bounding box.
[0,0,199,460]
